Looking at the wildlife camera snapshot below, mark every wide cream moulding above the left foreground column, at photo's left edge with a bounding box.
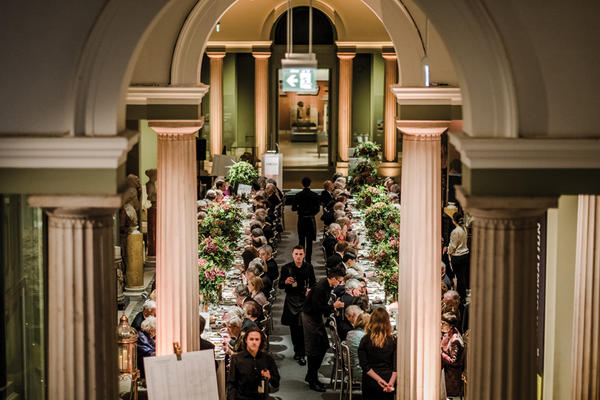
[0,131,140,169]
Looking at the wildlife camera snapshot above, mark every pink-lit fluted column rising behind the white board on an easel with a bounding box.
[148,120,203,355]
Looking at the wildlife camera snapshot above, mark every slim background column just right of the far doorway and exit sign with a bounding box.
[336,52,356,175]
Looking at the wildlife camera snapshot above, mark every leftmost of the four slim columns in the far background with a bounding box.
[206,51,225,157]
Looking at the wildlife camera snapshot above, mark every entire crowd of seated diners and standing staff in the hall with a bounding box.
[132,170,469,400]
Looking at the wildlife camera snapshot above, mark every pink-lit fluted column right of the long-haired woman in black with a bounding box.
[397,128,445,400]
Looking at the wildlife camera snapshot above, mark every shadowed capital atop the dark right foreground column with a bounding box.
[455,186,558,218]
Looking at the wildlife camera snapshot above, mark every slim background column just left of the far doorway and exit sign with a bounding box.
[252,51,271,170]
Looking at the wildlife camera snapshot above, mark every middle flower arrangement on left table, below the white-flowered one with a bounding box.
[198,201,242,243]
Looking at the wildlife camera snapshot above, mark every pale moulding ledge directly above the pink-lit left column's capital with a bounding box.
[127,84,208,105]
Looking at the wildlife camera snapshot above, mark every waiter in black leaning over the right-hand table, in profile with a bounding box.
[302,267,344,392]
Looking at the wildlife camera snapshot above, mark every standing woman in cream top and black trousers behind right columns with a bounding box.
[448,212,470,304]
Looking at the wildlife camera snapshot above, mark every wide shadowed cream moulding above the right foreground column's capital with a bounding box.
[450,132,600,169]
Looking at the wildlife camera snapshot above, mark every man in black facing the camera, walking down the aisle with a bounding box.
[279,245,316,365]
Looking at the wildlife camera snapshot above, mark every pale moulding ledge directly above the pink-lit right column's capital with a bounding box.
[391,85,462,105]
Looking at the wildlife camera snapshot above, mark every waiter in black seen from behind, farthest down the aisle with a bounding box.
[292,177,321,264]
